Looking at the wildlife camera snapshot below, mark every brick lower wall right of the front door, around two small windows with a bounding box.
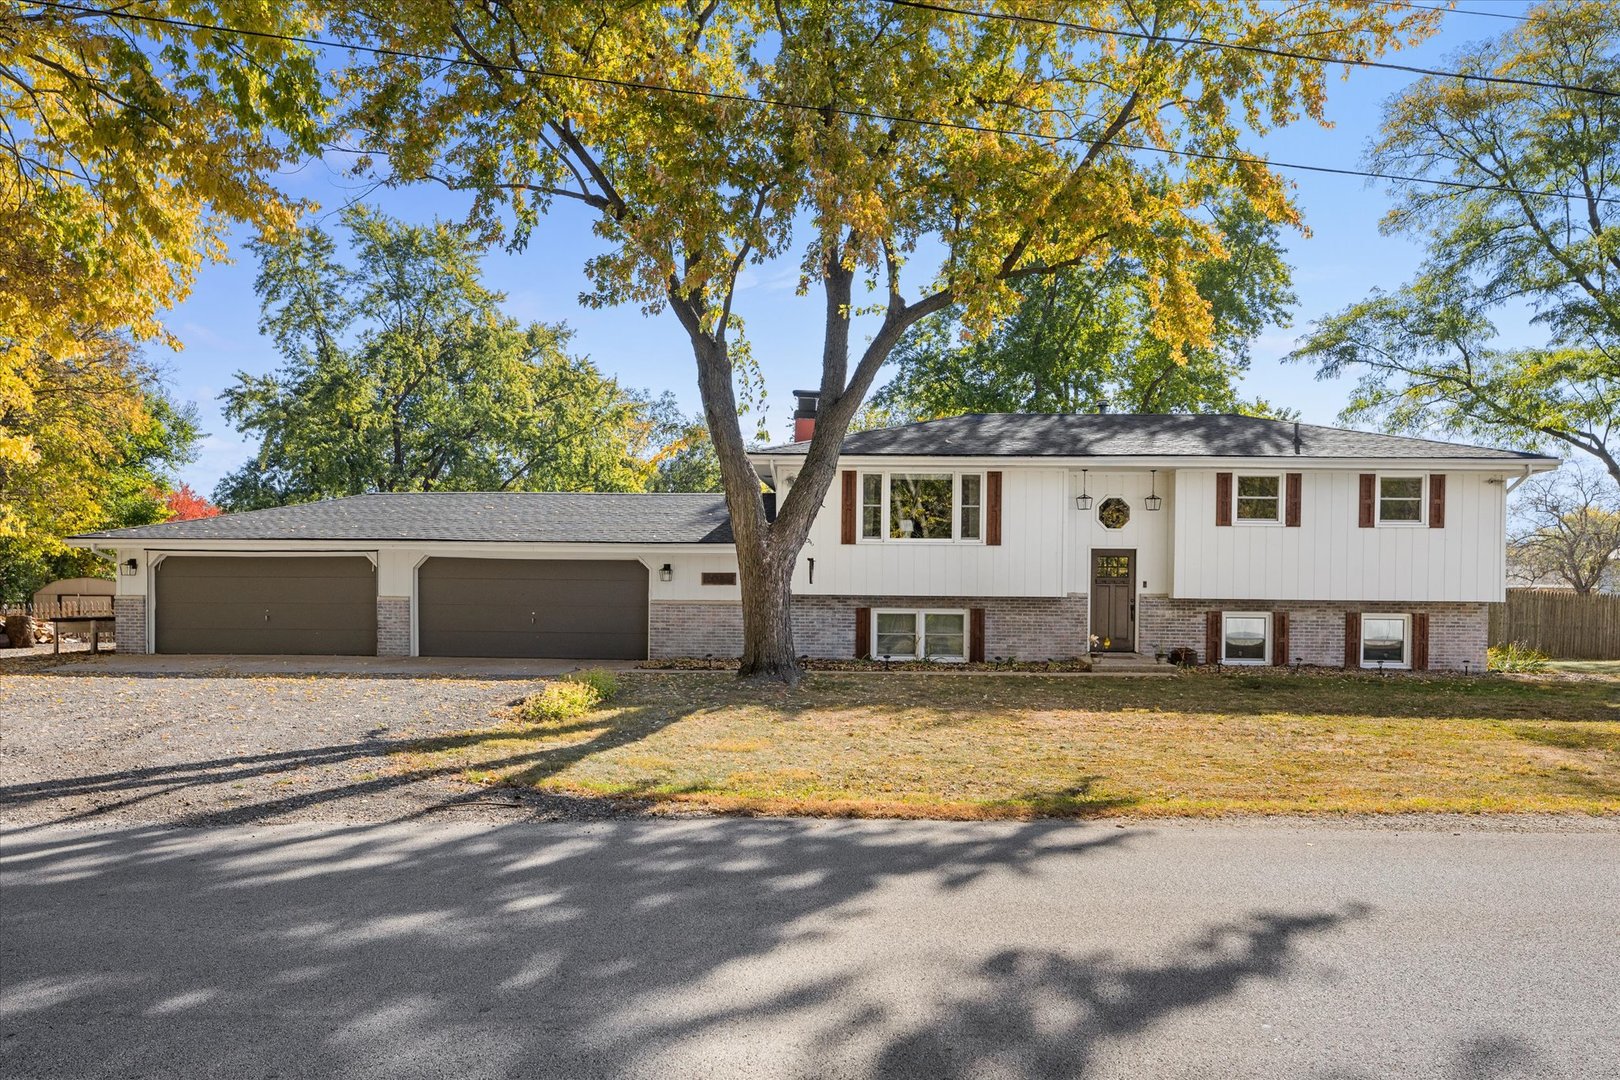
[1137,596,1489,670]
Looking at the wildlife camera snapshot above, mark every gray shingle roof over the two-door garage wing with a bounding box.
[75,491,732,544]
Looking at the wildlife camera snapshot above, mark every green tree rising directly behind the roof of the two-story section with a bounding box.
[873,196,1294,419]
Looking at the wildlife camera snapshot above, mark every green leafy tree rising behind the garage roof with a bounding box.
[215,207,654,510]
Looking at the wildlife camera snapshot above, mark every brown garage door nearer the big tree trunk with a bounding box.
[416,559,646,661]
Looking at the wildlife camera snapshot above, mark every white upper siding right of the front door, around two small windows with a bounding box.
[1170,466,1505,602]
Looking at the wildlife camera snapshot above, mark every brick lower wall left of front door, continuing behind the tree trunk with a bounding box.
[648,596,1087,661]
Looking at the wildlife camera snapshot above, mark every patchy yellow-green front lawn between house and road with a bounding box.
[400,672,1620,818]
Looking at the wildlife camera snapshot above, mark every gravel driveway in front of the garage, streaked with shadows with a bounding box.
[0,672,624,826]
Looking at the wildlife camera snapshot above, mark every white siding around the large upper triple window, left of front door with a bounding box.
[794,460,1074,597]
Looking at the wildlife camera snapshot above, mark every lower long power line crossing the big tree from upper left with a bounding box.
[25,0,1620,206]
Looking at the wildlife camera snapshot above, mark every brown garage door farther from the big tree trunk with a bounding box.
[152,555,377,656]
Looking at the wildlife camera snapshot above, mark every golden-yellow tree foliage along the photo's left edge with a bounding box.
[0,0,322,588]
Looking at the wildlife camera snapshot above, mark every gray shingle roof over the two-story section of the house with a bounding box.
[757,413,1542,461]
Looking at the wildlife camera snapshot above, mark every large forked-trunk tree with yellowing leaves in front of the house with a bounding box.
[335,0,1439,682]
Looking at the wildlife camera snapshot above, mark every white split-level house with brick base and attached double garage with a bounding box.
[73,404,1557,669]
